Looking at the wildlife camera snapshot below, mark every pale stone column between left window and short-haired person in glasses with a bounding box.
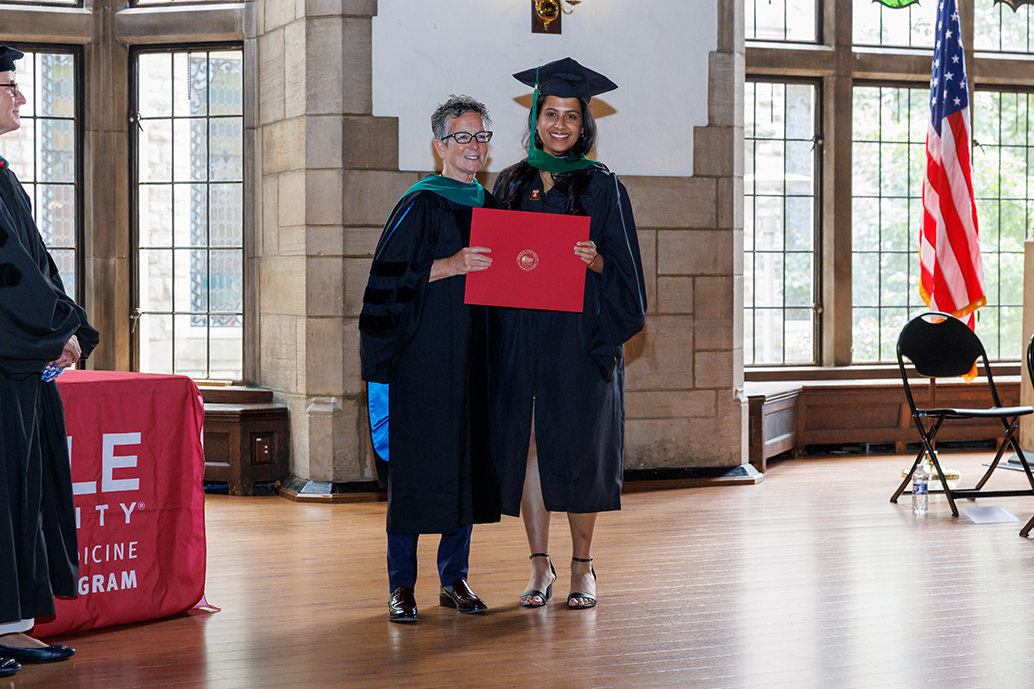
[255,0,394,487]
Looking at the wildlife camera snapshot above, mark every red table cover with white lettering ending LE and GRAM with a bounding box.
[33,370,206,636]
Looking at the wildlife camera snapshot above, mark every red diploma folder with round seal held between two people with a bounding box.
[464,208,589,312]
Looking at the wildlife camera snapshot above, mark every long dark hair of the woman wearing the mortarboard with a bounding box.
[495,96,597,215]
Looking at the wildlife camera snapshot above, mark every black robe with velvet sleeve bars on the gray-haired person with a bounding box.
[359,190,499,534]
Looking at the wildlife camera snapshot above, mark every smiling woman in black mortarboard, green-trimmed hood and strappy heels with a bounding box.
[488,58,646,609]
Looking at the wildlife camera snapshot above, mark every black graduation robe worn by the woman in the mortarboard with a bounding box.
[488,164,646,516]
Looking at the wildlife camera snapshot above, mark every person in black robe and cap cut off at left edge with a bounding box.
[0,46,98,677]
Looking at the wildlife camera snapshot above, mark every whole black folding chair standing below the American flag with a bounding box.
[890,311,1034,515]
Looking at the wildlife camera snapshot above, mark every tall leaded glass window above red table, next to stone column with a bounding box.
[135,50,244,381]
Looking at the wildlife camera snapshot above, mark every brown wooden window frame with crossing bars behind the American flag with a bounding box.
[744,0,1034,381]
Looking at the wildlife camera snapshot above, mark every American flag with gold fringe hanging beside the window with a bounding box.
[919,0,987,328]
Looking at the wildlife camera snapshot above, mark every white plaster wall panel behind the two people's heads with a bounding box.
[373,0,718,177]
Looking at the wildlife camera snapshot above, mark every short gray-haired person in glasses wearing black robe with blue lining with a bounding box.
[359,96,499,622]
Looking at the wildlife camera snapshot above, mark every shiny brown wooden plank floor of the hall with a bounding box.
[12,454,1034,689]
